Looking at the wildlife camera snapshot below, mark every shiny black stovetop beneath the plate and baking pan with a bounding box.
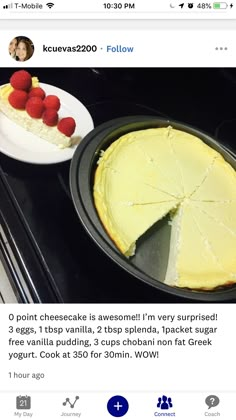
[0,68,236,303]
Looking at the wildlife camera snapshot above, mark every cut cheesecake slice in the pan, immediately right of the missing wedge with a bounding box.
[165,200,236,290]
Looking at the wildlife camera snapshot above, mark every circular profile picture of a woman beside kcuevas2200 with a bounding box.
[8,36,34,61]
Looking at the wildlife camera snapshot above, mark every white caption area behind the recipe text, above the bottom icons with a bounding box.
[0,304,236,391]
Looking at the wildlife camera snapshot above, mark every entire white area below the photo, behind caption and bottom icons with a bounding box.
[0,304,236,420]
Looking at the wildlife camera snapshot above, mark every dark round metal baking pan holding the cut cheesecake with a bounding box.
[70,116,236,302]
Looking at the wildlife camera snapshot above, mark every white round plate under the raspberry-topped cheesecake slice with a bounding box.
[0,83,94,164]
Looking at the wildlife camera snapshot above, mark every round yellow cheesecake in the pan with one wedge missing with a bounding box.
[94,127,236,290]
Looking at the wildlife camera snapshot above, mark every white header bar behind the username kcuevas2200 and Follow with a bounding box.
[0,29,236,68]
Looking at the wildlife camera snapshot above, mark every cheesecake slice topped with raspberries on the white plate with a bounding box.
[0,72,74,149]
